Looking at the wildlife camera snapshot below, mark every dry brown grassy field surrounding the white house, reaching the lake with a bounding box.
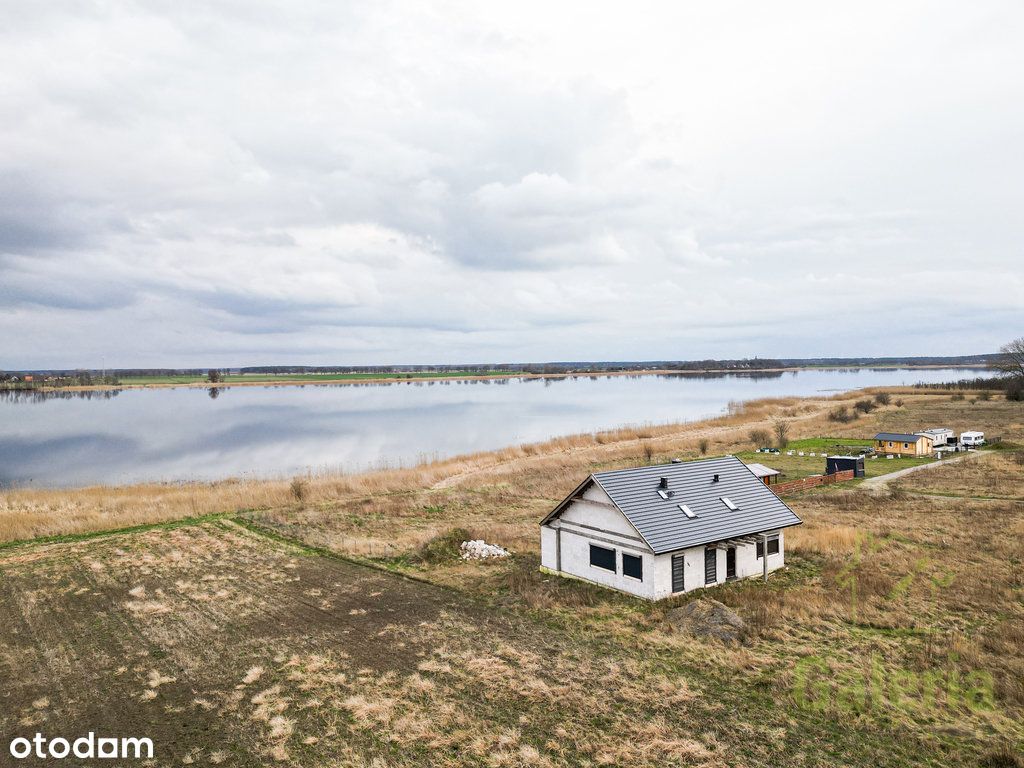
[0,392,1024,768]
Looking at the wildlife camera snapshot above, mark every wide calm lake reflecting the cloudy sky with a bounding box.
[0,369,978,487]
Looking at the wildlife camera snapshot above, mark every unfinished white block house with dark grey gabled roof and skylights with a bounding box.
[541,456,801,600]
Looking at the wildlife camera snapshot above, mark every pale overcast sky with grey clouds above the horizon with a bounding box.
[0,0,1024,369]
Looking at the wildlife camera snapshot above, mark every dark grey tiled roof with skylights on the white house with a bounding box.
[593,456,801,554]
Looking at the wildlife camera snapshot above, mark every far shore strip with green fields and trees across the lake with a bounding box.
[0,362,984,392]
